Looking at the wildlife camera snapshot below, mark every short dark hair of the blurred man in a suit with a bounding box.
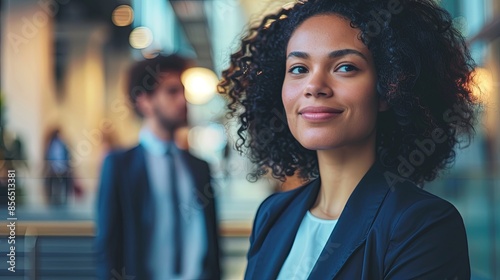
[127,54,189,116]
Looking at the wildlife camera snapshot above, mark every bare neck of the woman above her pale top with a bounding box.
[311,143,375,219]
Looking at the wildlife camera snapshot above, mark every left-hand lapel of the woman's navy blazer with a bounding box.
[252,179,320,279]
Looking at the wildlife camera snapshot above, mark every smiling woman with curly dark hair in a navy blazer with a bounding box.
[220,0,475,279]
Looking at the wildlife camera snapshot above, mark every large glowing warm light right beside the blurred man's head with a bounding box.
[181,67,219,105]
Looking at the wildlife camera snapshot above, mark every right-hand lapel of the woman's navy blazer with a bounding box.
[309,163,390,279]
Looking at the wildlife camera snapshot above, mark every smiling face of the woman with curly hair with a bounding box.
[282,15,383,150]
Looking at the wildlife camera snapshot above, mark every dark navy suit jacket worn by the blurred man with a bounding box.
[96,145,220,280]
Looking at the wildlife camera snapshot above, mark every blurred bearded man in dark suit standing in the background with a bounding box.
[96,55,220,280]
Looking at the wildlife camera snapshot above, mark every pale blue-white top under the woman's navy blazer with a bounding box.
[278,211,337,280]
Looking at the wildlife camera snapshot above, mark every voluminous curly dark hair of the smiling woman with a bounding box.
[219,0,477,184]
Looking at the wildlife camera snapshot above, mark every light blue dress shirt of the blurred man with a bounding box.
[139,128,207,280]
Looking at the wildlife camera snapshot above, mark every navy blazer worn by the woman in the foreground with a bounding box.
[245,164,470,280]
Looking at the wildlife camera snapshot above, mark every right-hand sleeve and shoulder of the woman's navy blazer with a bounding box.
[384,179,470,279]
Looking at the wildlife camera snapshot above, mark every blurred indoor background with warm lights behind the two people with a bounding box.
[0,0,500,280]
